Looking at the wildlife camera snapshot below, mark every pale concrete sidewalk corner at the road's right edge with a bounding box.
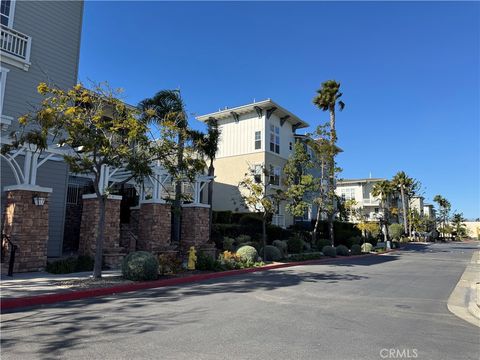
[447,250,480,327]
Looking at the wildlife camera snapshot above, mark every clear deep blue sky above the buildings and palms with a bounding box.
[79,1,480,218]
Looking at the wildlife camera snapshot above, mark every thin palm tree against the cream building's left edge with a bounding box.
[192,118,220,239]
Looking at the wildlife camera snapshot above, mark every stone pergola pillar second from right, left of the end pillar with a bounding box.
[137,200,172,253]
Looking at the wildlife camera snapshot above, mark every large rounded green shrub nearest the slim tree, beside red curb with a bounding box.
[122,251,159,281]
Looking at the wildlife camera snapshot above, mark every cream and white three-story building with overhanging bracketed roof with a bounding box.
[197,99,308,227]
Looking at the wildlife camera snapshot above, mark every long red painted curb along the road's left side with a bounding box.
[0,250,396,312]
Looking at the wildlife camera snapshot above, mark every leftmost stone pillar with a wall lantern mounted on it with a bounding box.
[3,185,52,272]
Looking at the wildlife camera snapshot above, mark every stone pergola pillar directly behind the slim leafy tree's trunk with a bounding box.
[78,194,122,257]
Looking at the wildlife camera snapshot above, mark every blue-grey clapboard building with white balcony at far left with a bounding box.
[0,0,83,256]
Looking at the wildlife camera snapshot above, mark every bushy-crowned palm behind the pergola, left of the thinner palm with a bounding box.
[139,90,188,242]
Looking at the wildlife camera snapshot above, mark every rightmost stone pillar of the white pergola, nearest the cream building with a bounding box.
[180,204,215,256]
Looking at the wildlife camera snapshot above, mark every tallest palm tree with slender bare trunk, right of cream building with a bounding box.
[313,80,345,246]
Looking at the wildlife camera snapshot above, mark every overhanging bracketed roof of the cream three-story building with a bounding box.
[196,99,309,129]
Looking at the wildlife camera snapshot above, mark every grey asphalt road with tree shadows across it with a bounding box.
[1,244,480,360]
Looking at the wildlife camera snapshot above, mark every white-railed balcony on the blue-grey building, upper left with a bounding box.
[0,25,32,71]
